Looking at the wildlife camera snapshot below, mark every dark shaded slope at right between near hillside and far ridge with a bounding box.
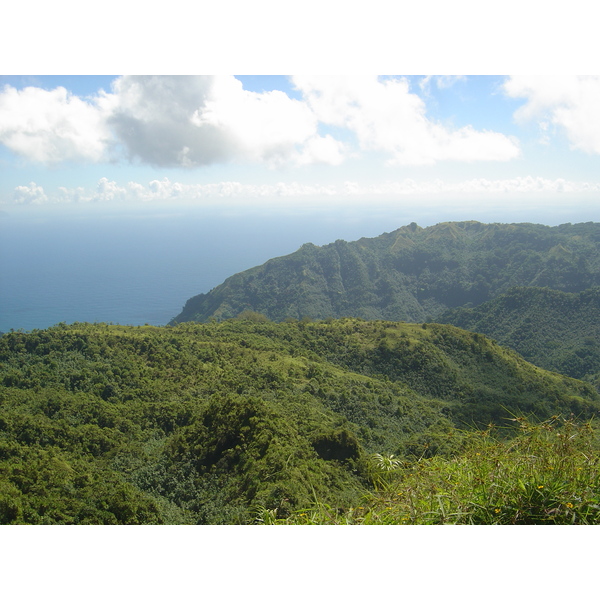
[437,288,600,384]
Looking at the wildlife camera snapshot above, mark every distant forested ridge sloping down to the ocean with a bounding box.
[172,221,600,323]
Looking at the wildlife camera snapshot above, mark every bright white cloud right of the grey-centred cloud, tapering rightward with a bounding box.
[293,76,519,165]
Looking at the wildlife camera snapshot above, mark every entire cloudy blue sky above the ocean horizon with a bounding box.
[0,72,600,224]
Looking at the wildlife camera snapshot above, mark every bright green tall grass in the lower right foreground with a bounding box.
[265,417,600,525]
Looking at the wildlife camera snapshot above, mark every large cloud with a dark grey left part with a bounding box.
[109,76,341,167]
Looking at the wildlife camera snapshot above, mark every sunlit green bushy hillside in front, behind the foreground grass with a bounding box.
[0,313,600,524]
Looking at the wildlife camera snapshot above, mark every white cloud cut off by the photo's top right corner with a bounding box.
[503,75,600,154]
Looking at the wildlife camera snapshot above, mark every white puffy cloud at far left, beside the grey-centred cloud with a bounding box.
[0,86,110,164]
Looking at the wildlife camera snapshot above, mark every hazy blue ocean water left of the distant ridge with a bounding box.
[0,206,418,332]
